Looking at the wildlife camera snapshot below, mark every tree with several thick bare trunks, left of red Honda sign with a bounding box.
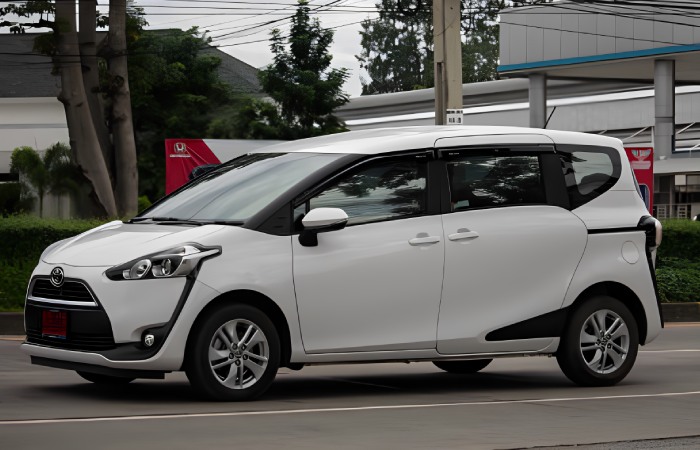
[0,0,142,216]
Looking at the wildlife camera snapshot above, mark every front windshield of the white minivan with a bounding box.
[140,153,344,224]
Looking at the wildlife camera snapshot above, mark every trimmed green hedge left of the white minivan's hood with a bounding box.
[0,216,104,311]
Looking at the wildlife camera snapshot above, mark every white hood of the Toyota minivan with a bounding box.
[41,221,230,267]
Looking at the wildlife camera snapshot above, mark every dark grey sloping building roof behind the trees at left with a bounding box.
[0,33,262,98]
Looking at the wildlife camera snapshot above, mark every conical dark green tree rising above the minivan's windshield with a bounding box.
[245,0,349,139]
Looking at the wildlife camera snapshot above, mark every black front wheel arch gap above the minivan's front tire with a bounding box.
[183,290,292,368]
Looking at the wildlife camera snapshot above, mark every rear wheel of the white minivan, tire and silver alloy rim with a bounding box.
[556,296,639,386]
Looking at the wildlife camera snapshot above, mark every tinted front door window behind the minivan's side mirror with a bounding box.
[309,158,427,225]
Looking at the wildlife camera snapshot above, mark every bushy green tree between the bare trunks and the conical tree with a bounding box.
[128,28,244,199]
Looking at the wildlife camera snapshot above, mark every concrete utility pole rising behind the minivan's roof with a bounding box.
[433,0,463,125]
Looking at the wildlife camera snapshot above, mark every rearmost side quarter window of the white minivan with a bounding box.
[557,145,622,209]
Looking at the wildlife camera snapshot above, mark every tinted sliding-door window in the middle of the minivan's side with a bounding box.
[447,154,545,211]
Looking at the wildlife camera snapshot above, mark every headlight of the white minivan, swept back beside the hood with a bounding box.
[105,244,221,281]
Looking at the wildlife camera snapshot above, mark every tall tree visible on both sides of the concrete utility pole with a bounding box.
[357,0,551,94]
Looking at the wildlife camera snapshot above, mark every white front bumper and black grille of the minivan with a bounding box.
[21,263,217,372]
